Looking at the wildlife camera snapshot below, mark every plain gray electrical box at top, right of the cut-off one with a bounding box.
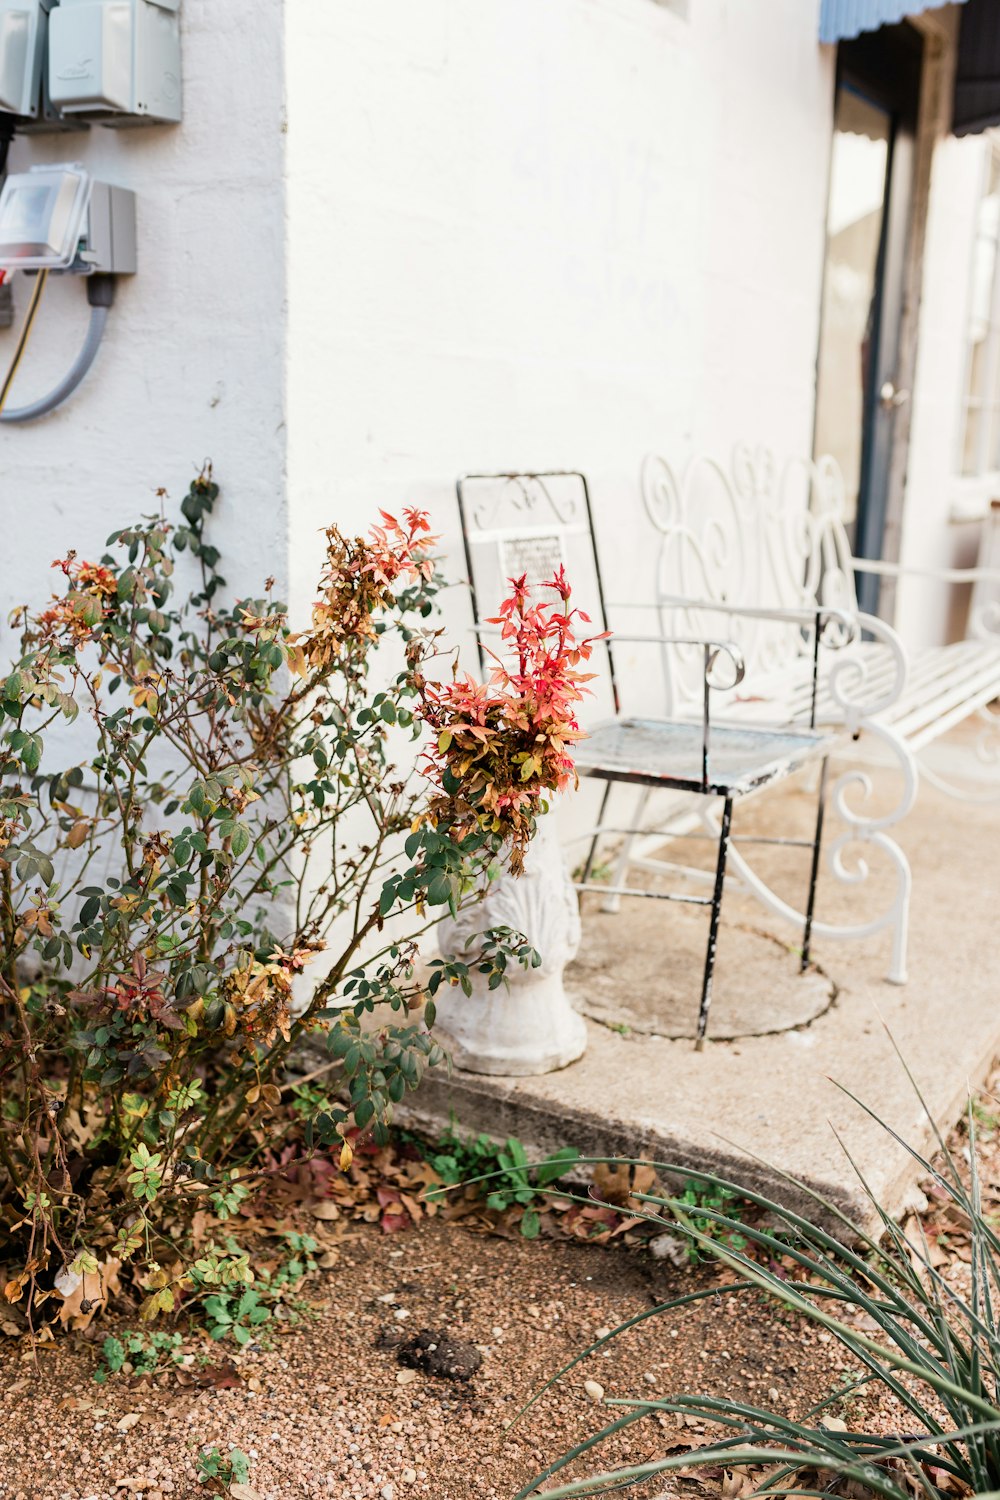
[48,0,180,125]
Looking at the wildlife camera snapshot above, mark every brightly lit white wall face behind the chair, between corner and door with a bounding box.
[286,0,834,690]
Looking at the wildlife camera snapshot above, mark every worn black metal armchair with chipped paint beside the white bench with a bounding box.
[457,470,844,1050]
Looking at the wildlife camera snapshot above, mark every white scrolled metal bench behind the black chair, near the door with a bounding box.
[606,447,1000,983]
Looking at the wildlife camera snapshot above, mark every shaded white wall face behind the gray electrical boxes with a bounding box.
[0,0,288,639]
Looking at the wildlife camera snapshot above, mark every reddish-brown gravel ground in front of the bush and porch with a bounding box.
[0,1220,869,1500]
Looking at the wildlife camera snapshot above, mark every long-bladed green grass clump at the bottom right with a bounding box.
[517,1056,1000,1500]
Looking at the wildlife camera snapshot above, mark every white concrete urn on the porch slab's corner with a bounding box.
[435,813,586,1077]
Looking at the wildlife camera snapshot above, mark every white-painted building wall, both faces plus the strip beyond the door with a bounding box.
[0,0,982,687]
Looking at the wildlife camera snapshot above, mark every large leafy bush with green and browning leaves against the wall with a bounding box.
[0,473,587,1322]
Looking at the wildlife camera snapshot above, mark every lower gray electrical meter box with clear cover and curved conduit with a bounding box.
[0,162,136,276]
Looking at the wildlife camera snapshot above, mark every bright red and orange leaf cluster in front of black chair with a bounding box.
[421,567,604,875]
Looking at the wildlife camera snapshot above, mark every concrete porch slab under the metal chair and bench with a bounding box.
[408,734,1000,1223]
